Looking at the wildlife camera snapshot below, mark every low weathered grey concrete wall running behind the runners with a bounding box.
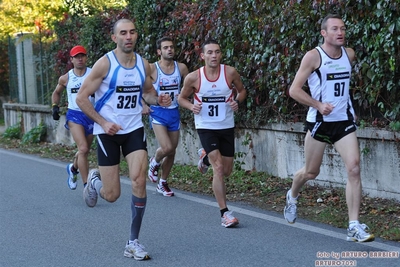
[3,103,400,200]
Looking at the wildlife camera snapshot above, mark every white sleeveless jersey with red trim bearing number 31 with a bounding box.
[194,64,235,130]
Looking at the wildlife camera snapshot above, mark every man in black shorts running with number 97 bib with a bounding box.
[284,14,375,242]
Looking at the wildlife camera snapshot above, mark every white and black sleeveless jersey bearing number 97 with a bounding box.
[307,47,354,122]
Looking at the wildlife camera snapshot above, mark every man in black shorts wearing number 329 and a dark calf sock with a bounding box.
[76,19,171,260]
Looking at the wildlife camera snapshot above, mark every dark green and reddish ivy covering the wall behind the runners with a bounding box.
[50,0,400,128]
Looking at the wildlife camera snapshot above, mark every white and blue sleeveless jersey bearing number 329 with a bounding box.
[93,51,146,135]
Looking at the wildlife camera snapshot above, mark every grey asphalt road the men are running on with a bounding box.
[0,149,400,267]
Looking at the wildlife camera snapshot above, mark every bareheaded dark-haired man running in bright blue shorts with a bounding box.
[148,37,188,197]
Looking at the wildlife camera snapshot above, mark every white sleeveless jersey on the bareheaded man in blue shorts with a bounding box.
[151,61,182,108]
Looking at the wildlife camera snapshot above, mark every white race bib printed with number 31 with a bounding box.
[200,96,226,122]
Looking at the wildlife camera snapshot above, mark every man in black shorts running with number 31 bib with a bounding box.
[178,39,246,227]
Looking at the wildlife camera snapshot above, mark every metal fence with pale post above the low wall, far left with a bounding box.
[8,33,58,105]
